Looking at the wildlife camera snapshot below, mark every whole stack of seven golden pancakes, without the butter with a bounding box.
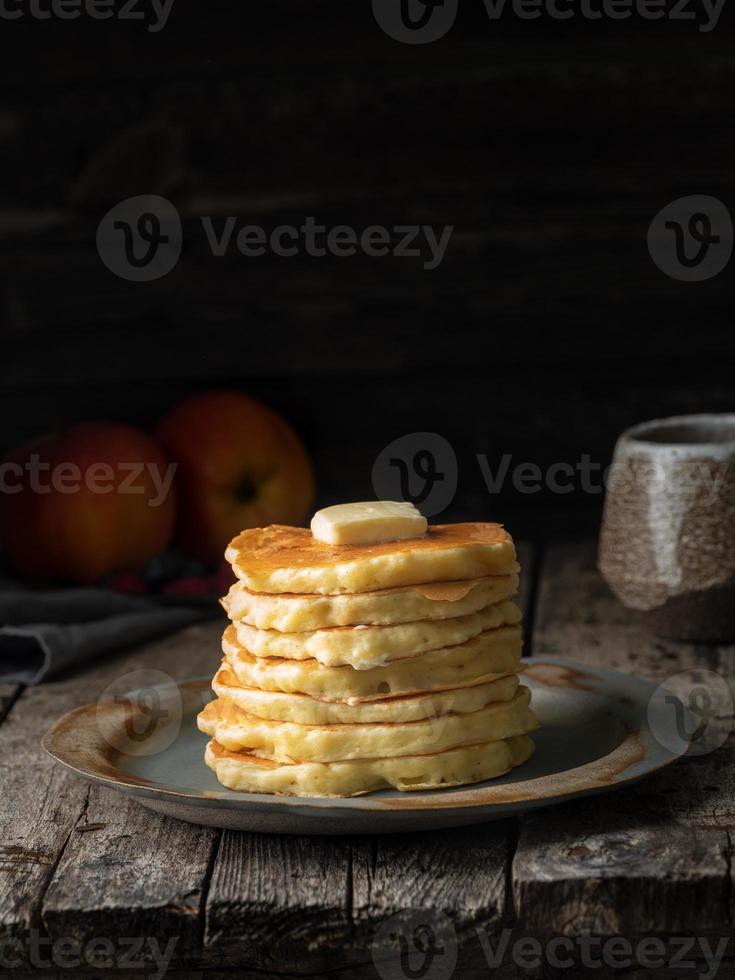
[199,524,538,796]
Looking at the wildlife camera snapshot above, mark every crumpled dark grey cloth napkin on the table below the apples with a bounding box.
[0,580,217,684]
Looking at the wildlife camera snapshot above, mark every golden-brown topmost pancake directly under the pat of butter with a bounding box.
[225,524,516,595]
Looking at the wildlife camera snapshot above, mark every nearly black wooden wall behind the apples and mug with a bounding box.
[0,0,735,537]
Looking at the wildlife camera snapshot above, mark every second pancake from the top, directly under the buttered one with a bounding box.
[222,566,518,633]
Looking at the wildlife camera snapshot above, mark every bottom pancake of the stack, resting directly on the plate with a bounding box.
[205,735,534,797]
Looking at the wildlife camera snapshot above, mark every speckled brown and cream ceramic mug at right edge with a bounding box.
[598,414,735,642]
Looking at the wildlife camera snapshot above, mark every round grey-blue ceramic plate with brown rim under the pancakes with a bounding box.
[43,658,686,834]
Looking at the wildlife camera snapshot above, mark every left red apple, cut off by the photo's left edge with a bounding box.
[0,422,175,584]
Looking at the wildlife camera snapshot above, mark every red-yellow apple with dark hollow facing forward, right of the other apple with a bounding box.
[157,391,314,561]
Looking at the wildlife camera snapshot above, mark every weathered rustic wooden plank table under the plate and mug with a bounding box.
[0,544,735,980]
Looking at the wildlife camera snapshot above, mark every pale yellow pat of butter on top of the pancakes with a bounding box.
[311,500,427,544]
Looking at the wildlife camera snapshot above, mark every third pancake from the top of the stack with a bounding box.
[236,601,522,670]
